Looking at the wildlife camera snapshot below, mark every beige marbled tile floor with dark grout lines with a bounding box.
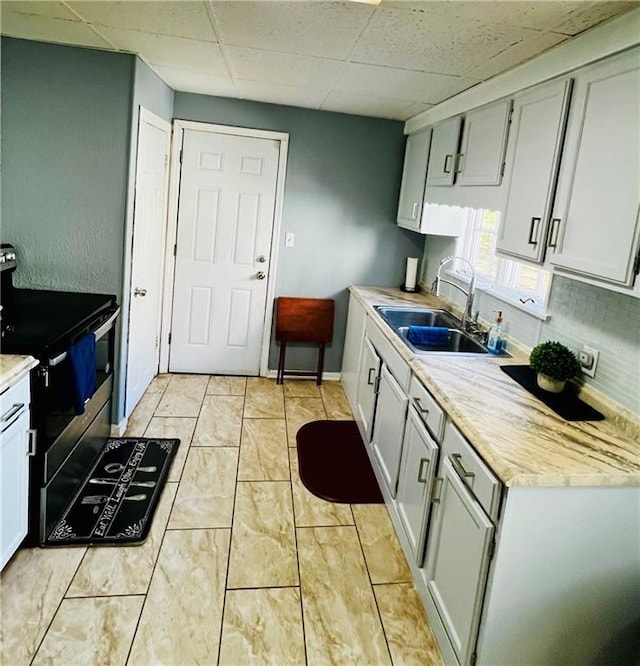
[0,375,442,666]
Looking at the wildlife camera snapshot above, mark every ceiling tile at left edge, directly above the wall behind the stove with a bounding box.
[1,11,112,49]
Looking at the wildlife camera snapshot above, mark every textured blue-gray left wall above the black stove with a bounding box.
[1,38,135,297]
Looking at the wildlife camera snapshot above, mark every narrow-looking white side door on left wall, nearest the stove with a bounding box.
[125,108,171,415]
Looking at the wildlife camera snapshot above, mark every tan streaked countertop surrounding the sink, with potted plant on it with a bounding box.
[350,287,640,486]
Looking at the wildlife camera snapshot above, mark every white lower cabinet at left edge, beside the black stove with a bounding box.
[0,374,29,569]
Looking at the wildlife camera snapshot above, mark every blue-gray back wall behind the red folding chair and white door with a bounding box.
[174,92,424,372]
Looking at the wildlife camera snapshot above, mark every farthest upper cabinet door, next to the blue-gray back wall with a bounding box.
[398,127,431,231]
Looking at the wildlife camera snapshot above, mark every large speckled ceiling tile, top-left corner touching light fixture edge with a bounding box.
[350,7,535,75]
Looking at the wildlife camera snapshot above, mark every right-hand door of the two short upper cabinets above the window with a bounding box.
[457,99,512,185]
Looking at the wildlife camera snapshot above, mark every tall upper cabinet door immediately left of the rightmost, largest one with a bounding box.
[497,79,572,262]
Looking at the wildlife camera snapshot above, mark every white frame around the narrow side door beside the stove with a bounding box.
[123,104,172,418]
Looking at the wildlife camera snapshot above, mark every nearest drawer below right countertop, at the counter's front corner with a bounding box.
[442,421,502,520]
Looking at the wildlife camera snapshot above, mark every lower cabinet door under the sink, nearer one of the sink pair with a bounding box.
[371,365,409,497]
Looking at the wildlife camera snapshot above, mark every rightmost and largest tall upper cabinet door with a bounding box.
[548,49,640,286]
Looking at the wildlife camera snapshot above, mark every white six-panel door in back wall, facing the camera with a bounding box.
[169,130,280,375]
